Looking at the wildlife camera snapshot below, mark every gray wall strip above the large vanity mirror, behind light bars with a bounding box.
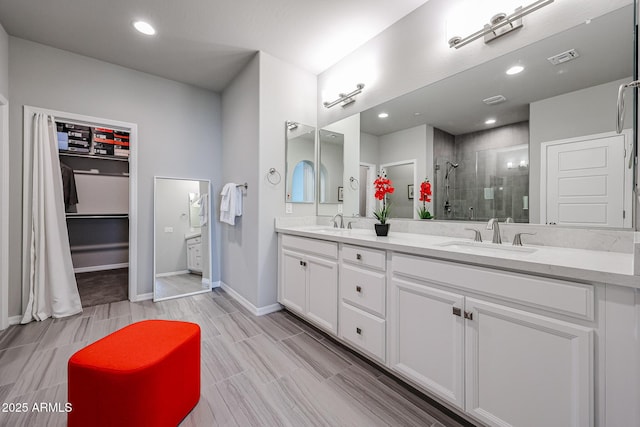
[318,0,631,127]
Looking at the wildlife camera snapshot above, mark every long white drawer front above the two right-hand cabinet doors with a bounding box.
[392,253,595,320]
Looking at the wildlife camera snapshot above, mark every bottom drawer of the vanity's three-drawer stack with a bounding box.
[340,302,385,362]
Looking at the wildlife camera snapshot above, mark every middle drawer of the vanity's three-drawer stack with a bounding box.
[340,264,386,317]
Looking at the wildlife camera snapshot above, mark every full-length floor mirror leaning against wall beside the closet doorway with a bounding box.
[153,177,211,301]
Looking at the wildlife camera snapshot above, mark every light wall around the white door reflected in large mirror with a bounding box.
[529,77,633,224]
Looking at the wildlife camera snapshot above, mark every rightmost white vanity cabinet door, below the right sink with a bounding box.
[465,298,594,427]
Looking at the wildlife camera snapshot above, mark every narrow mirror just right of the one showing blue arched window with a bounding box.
[318,129,345,204]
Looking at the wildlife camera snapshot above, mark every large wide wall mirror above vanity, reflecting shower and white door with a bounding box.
[345,0,634,228]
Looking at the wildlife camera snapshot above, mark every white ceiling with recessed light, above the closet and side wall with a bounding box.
[0,0,427,91]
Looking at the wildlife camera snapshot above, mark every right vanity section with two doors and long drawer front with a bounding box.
[387,253,595,427]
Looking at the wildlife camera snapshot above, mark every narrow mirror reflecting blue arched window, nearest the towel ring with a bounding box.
[285,121,316,203]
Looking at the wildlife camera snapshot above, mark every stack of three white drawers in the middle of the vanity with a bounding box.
[339,244,386,363]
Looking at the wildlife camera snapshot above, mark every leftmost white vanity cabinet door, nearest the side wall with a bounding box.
[280,249,307,314]
